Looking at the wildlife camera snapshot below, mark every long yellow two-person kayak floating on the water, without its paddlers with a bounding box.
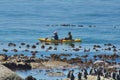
[38,38,82,43]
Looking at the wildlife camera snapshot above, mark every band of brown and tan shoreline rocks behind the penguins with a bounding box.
[0,53,120,70]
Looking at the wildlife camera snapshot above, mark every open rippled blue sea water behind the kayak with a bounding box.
[0,0,120,77]
